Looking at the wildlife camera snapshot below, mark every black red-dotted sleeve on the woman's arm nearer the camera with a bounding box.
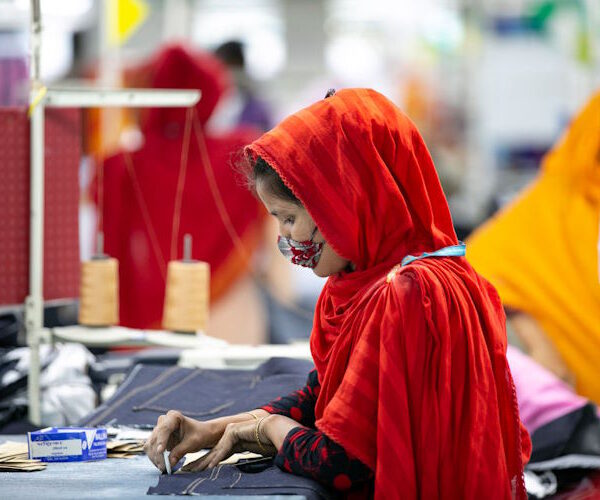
[275,427,374,491]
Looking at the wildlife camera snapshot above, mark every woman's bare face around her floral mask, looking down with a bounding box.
[256,179,350,277]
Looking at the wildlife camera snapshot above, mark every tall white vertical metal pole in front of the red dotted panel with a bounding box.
[25,0,44,425]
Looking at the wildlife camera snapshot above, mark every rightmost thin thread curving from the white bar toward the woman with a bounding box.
[194,113,314,320]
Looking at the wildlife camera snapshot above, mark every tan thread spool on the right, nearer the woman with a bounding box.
[162,234,210,333]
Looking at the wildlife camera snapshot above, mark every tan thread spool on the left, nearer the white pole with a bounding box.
[79,233,119,326]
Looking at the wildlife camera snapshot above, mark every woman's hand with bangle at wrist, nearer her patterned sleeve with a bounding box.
[185,415,300,471]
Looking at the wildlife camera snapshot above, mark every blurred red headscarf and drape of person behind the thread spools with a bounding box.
[103,45,264,328]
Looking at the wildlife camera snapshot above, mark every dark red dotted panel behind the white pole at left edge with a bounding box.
[0,108,81,305]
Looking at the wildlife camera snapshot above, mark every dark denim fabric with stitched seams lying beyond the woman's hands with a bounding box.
[81,358,313,427]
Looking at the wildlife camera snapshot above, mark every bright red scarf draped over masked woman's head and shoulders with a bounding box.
[247,89,531,499]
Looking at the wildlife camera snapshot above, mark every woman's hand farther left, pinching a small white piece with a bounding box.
[144,410,220,472]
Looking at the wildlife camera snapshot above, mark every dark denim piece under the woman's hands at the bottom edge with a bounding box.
[148,459,335,500]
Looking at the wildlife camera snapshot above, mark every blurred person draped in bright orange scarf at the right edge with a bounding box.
[467,93,600,403]
